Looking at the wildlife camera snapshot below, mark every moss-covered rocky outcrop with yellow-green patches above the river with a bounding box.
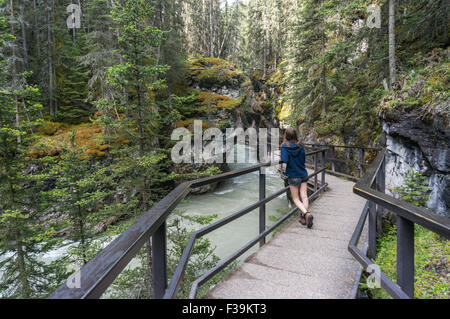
[187,58,278,129]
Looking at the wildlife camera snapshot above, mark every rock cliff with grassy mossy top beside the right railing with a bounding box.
[380,50,450,217]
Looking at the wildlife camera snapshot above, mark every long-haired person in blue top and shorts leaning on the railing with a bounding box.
[281,128,314,228]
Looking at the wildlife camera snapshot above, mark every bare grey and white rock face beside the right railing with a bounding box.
[382,109,450,217]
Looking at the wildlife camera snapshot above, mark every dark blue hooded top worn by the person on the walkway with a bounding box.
[281,142,308,178]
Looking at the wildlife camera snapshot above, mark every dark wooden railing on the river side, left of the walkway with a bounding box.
[50,148,327,299]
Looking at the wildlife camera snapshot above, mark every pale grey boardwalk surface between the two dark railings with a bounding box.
[206,174,365,299]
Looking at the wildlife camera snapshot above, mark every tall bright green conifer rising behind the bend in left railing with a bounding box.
[98,0,171,210]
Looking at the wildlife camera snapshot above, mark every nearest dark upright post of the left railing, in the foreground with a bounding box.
[152,221,167,299]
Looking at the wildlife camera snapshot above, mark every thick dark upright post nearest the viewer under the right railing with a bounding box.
[397,215,414,298]
